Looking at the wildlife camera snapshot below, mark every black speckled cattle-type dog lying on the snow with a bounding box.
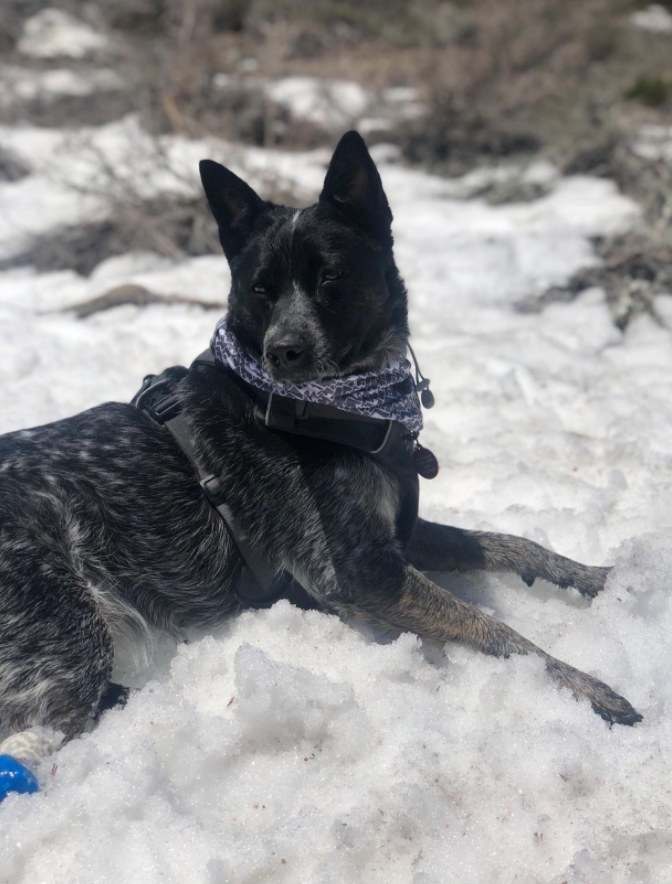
[0,132,641,772]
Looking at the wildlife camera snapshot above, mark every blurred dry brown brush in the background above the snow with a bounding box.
[5,0,672,324]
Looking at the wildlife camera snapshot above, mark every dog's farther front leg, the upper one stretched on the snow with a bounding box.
[405,519,610,598]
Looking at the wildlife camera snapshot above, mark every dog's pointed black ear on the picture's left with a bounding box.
[198,160,264,262]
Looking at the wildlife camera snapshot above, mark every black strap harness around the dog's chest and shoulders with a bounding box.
[131,350,433,607]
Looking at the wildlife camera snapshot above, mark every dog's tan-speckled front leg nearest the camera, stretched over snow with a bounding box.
[339,566,642,724]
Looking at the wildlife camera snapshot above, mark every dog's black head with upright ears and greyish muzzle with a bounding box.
[200,132,408,381]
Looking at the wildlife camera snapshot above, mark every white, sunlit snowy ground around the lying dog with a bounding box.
[0,74,672,884]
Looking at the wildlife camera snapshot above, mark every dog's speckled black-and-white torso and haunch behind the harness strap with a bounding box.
[0,404,242,735]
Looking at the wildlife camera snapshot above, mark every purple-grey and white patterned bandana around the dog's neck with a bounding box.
[212,323,422,433]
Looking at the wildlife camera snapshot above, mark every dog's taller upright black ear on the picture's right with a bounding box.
[320,132,392,243]
